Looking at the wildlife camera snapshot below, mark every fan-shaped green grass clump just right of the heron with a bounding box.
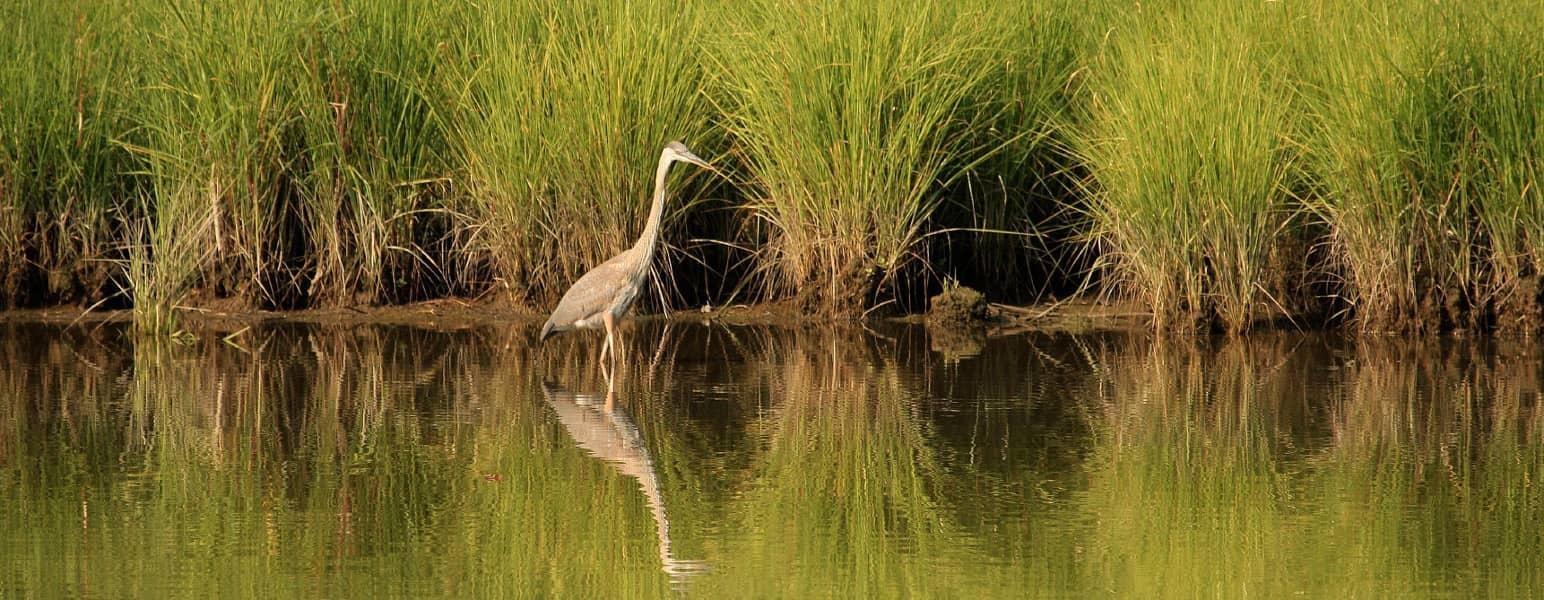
[720,0,1031,310]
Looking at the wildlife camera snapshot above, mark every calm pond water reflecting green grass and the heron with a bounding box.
[0,322,1544,598]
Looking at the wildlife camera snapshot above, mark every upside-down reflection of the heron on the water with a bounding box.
[542,378,704,585]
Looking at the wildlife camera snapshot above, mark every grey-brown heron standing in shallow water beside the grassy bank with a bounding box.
[540,142,713,364]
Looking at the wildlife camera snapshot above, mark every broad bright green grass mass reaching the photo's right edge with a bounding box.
[1078,2,1541,332]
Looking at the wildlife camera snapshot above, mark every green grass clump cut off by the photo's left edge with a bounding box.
[0,0,136,307]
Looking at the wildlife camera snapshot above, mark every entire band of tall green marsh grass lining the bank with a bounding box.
[0,0,1544,332]
